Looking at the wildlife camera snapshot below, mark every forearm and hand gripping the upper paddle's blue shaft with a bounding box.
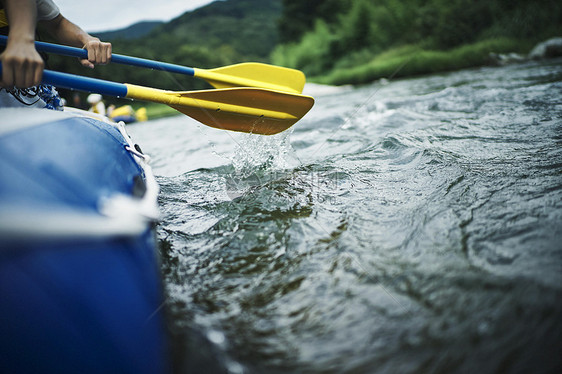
[41,14,111,68]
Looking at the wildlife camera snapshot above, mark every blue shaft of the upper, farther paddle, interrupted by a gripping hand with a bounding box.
[0,35,195,76]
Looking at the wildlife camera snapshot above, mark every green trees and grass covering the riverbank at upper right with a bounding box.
[272,0,562,84]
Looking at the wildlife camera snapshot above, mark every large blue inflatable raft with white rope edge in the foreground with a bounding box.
[0,108,171,374]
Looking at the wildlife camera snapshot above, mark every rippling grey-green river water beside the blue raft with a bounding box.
[129,60,562,373]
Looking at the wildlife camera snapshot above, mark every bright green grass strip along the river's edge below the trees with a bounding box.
[309,38,532,85]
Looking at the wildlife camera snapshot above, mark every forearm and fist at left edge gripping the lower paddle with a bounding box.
[0,0,44,88]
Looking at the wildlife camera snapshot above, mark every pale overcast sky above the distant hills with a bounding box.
[54,0,217,32]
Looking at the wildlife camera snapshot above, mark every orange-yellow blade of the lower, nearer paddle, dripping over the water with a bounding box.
[126,84,314,135]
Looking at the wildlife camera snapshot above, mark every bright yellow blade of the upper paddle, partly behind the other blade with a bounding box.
[194,62,306,93]
